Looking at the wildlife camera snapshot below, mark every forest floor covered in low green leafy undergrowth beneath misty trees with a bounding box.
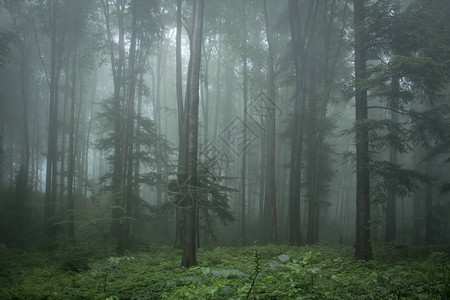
[0,244,450,299]
